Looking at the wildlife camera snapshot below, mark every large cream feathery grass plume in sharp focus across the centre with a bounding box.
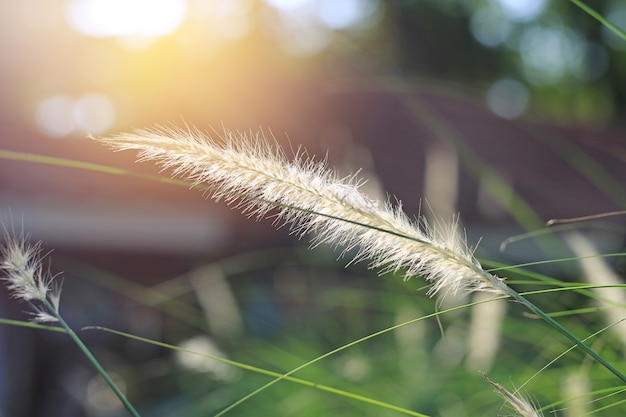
[96,126,509,295]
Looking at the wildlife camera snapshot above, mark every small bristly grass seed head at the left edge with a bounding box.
[0,230,61,323]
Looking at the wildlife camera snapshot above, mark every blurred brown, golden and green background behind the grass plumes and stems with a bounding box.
[0,0,626,417]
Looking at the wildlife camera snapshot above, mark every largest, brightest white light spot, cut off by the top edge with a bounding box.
[67,0,187,37]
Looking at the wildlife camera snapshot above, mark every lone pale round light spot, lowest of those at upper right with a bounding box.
[487,78,530,119]
